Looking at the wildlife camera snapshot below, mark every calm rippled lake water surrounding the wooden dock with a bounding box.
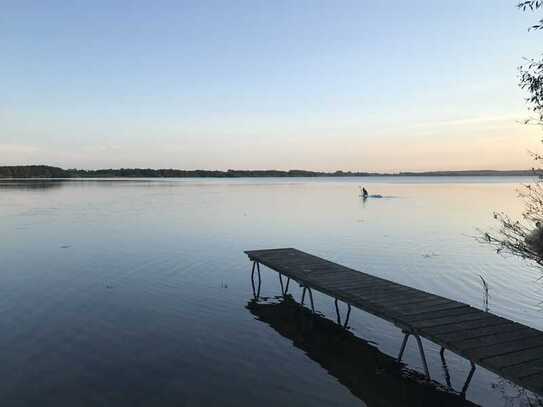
[0,177,543,407]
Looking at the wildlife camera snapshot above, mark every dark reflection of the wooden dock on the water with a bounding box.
[247,296,476,407]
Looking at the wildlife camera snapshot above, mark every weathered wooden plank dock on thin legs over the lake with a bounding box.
[245,248,543,395]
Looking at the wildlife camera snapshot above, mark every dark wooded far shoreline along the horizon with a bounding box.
[0,165,539,178]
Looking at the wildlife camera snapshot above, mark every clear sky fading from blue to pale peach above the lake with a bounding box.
[0,0,543,172]
